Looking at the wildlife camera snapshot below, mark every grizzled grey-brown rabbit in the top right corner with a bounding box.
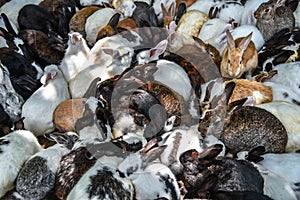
[254,0,295,41]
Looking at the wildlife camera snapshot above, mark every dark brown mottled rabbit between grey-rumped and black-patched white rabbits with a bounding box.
[54,140,125,199]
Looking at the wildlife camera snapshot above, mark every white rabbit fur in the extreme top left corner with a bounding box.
[0,0,42,28]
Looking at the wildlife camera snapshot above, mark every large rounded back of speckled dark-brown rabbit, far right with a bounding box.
[220,106,288,154]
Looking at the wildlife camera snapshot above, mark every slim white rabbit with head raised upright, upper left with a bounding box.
[59,32,90,82]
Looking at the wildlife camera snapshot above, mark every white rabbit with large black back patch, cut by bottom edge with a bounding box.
[67,156,134,200]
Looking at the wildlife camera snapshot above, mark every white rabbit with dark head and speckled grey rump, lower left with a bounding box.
[15,132,78,200]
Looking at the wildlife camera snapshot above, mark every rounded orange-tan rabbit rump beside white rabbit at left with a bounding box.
[53,98,87,132]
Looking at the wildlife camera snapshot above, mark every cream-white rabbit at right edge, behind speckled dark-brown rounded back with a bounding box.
[256,101,300,152]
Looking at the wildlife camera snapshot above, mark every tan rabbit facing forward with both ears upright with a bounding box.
[220,30,258,78]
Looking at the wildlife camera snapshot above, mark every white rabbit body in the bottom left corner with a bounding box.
[0,130,42,198]
